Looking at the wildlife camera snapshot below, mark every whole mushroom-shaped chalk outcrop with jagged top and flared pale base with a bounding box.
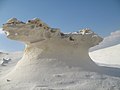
[3,18,102,84]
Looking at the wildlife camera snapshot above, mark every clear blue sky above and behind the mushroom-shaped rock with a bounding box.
[0,0,120,51]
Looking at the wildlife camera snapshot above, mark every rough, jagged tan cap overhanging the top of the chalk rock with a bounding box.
[3,18,102,47]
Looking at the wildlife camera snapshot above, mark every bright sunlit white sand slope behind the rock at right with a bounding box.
[90,44,120,66]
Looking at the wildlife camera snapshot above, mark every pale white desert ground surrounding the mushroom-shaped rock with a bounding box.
[0,44,120,90]
